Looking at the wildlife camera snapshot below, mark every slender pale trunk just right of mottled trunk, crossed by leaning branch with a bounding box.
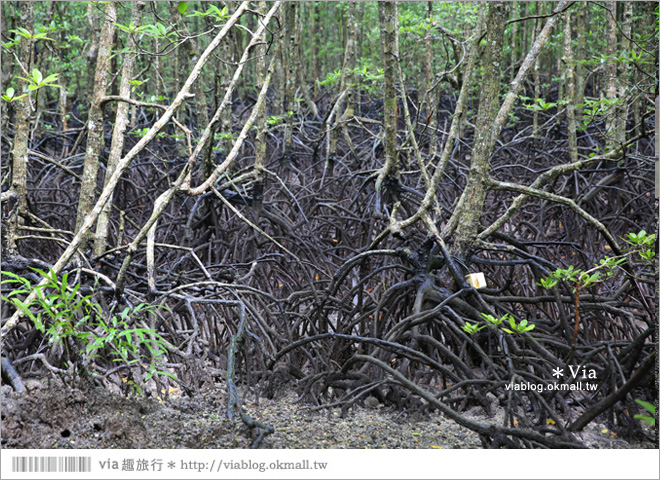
[94,2,144,256]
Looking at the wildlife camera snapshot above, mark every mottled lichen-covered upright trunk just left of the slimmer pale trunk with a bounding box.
[76,2,117,250]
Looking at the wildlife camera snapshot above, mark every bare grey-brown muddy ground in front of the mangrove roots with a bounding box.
[1,381,653,449]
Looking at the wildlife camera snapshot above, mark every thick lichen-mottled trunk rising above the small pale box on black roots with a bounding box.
[455,2,507,257]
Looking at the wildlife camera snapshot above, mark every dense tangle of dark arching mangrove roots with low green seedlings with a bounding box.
[2,73,657,447]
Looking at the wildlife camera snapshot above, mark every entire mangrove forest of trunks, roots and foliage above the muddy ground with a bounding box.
[0,0,658,448]
